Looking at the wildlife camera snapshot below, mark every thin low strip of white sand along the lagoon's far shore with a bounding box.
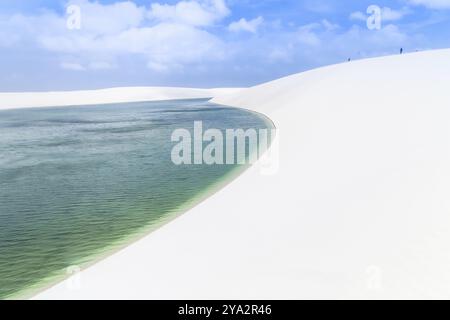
[0,87,241,110]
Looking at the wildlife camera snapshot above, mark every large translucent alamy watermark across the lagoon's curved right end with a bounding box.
[171,121,279,174]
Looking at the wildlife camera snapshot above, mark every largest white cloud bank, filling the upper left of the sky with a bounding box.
[0,0,229,72]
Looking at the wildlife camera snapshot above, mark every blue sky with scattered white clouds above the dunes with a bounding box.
[0,0,450,91]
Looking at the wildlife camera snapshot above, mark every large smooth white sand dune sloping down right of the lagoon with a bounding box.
[32,50,450,299]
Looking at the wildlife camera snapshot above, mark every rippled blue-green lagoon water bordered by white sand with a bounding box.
[0,100,269,299]
